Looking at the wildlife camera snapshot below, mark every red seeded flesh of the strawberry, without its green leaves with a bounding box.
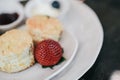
[35,40,63,66]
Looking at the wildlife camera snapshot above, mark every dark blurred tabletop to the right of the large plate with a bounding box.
[80,0,120,80]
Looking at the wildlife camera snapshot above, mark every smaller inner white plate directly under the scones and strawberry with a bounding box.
[0,26,78,80]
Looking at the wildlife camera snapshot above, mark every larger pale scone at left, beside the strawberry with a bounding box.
[0,29,35,73]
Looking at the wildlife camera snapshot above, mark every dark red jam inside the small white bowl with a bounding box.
[0,13,19,25]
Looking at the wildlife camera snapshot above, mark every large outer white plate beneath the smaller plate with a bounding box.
[50,1,103,80]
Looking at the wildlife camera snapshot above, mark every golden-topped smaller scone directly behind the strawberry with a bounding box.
[26,15,63,42]
